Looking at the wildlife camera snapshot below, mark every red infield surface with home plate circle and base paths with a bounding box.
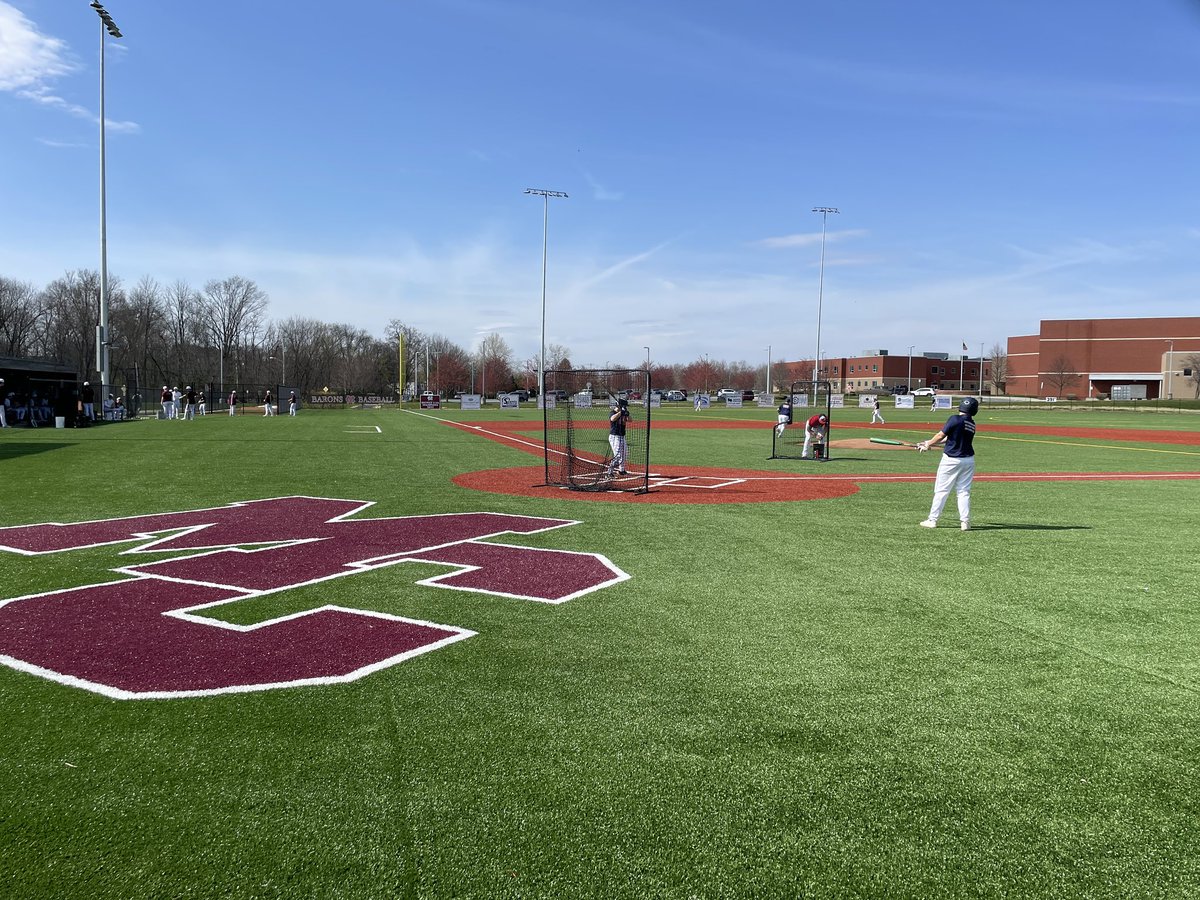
[446,420,1200,504]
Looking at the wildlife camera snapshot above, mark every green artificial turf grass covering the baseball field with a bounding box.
[0,407,1200,898]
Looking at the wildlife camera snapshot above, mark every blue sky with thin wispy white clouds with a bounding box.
[0,0,1200,365]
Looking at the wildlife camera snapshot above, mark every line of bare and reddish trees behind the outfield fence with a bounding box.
[0,269,768,395]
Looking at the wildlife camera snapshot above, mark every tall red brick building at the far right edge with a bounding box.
[1004,317,1200,400]
